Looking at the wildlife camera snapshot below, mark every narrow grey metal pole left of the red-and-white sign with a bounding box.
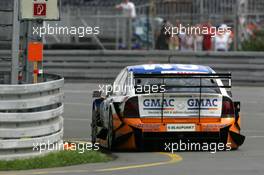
[11,0,20,84]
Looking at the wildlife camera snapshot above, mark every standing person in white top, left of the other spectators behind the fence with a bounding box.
[115,0,136,49]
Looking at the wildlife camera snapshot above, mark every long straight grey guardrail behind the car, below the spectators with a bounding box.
[0,50,264,86]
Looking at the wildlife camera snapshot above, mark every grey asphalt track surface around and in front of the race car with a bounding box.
[0,83,264,175]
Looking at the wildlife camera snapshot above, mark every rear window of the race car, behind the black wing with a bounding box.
[135,78,220,93]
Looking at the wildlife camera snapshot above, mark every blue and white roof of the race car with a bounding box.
[127,64,213,74]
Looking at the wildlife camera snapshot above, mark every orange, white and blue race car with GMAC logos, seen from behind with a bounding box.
[91,64,245,150]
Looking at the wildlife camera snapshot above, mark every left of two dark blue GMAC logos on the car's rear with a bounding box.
[143,99,175,108]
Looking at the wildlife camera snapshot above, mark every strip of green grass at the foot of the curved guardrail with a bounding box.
[0,151,112,171]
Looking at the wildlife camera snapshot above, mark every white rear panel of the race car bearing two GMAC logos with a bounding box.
[139,95,222,117]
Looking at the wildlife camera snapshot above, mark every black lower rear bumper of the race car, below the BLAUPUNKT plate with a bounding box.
[134,126,245,151]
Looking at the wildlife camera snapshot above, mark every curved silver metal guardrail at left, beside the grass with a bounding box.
[0,75,64,160]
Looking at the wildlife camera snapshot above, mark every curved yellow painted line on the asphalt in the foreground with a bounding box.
[5,153,183,175]
